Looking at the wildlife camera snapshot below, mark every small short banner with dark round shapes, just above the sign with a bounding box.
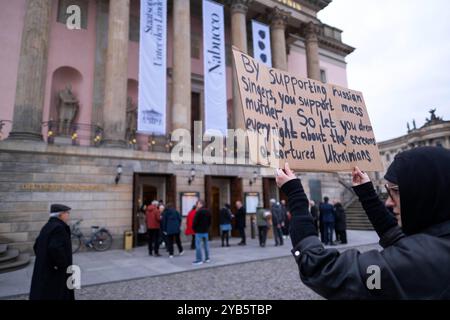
[252,20,272,68]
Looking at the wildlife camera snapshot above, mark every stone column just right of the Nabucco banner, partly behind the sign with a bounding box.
[229,0,252,129]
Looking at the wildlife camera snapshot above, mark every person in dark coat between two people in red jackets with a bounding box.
[162,203,184,258]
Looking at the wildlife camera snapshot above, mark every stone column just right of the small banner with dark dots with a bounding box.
[269,7,290,70]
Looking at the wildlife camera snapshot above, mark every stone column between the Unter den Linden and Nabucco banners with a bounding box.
[172,0,191,131]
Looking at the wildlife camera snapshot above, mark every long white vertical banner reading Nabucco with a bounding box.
[203,0,227,135]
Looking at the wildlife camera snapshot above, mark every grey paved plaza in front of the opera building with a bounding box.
[0,230,378,299]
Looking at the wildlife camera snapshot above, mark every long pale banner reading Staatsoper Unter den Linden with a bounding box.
[138,0,167,134]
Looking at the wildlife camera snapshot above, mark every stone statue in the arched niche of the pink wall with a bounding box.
[58,84,80,136]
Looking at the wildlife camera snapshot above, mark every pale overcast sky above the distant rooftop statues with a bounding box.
[319,0,450,141]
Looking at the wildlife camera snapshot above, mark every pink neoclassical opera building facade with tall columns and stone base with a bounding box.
[0,0,354,249]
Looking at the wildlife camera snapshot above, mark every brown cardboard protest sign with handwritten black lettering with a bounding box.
[233,47,383,172]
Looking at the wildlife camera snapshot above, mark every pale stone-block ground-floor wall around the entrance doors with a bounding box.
[0,141,262,251]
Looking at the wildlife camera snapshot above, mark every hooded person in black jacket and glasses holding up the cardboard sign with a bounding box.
[277,147,450,300]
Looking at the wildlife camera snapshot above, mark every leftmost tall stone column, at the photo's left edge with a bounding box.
[9,0,53,141]
